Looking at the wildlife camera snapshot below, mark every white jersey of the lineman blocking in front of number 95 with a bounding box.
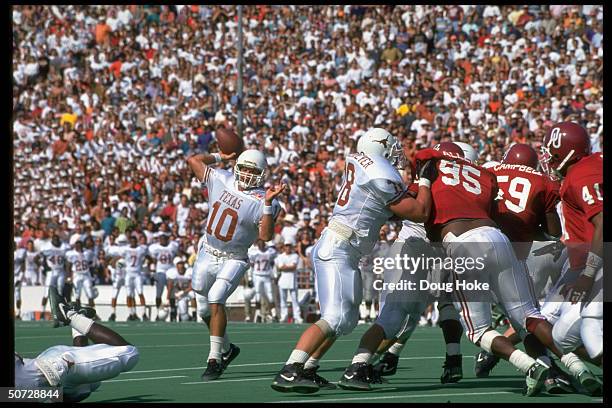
[330,153,406,254]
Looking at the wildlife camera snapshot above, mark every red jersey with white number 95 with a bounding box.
[425,152,498,241]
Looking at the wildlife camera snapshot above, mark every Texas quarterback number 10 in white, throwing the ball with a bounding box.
[188,150,285,381]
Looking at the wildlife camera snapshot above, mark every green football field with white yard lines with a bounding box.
[15,322,602,403]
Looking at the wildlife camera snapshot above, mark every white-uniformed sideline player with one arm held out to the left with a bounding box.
[107,235,149,320]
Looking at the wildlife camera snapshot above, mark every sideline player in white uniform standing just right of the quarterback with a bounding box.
[249,239,277,323]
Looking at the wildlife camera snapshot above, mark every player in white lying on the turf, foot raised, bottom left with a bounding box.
[15,287,139,402]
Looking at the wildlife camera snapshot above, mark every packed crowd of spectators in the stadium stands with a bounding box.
[12,5,603,290]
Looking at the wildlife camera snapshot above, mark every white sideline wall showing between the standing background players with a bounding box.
[16,285,310,321]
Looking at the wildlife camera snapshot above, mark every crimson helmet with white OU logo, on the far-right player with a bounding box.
[540,122,591,176]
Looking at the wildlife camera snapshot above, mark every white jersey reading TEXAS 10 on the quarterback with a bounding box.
[203,167,280,258]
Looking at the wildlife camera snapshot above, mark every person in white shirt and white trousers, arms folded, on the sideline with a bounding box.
[274,242,302,324]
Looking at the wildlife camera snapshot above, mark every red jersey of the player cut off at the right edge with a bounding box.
[559,153,603,268]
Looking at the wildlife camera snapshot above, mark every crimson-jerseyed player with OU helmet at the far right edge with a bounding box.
[540,122,603,395]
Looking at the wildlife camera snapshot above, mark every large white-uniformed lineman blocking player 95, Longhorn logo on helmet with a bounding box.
[271,128,435,393]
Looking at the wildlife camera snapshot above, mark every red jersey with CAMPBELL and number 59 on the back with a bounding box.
[489,164,559,259]
